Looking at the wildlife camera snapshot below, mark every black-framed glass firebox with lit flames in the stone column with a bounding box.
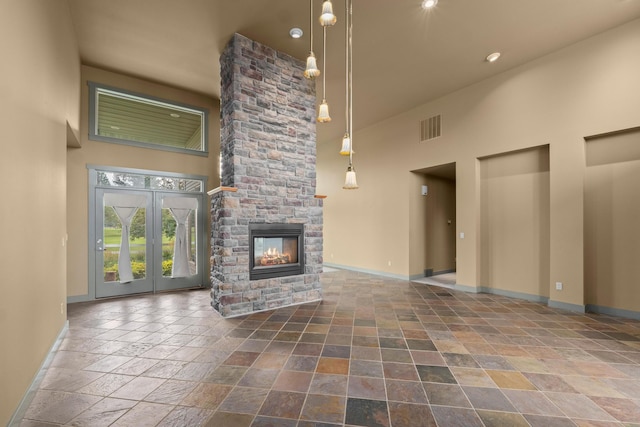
[249,224,304,280]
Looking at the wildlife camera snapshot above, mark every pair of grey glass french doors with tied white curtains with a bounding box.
[90,167,206,298]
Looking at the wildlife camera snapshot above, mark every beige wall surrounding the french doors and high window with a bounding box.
[67,66,220,296]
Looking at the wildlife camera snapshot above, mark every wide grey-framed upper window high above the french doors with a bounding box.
[89,82,208,155]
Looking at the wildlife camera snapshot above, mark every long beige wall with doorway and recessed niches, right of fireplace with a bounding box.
[318,20,640,308]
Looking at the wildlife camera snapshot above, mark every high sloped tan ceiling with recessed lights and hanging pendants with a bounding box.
[68,0,640,142]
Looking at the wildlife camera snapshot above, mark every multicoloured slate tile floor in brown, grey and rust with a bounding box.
[21,271,640,427]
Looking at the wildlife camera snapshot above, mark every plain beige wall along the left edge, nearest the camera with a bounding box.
[0,0,80,425]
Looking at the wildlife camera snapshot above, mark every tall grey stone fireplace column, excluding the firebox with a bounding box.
[210,34,322,317]
